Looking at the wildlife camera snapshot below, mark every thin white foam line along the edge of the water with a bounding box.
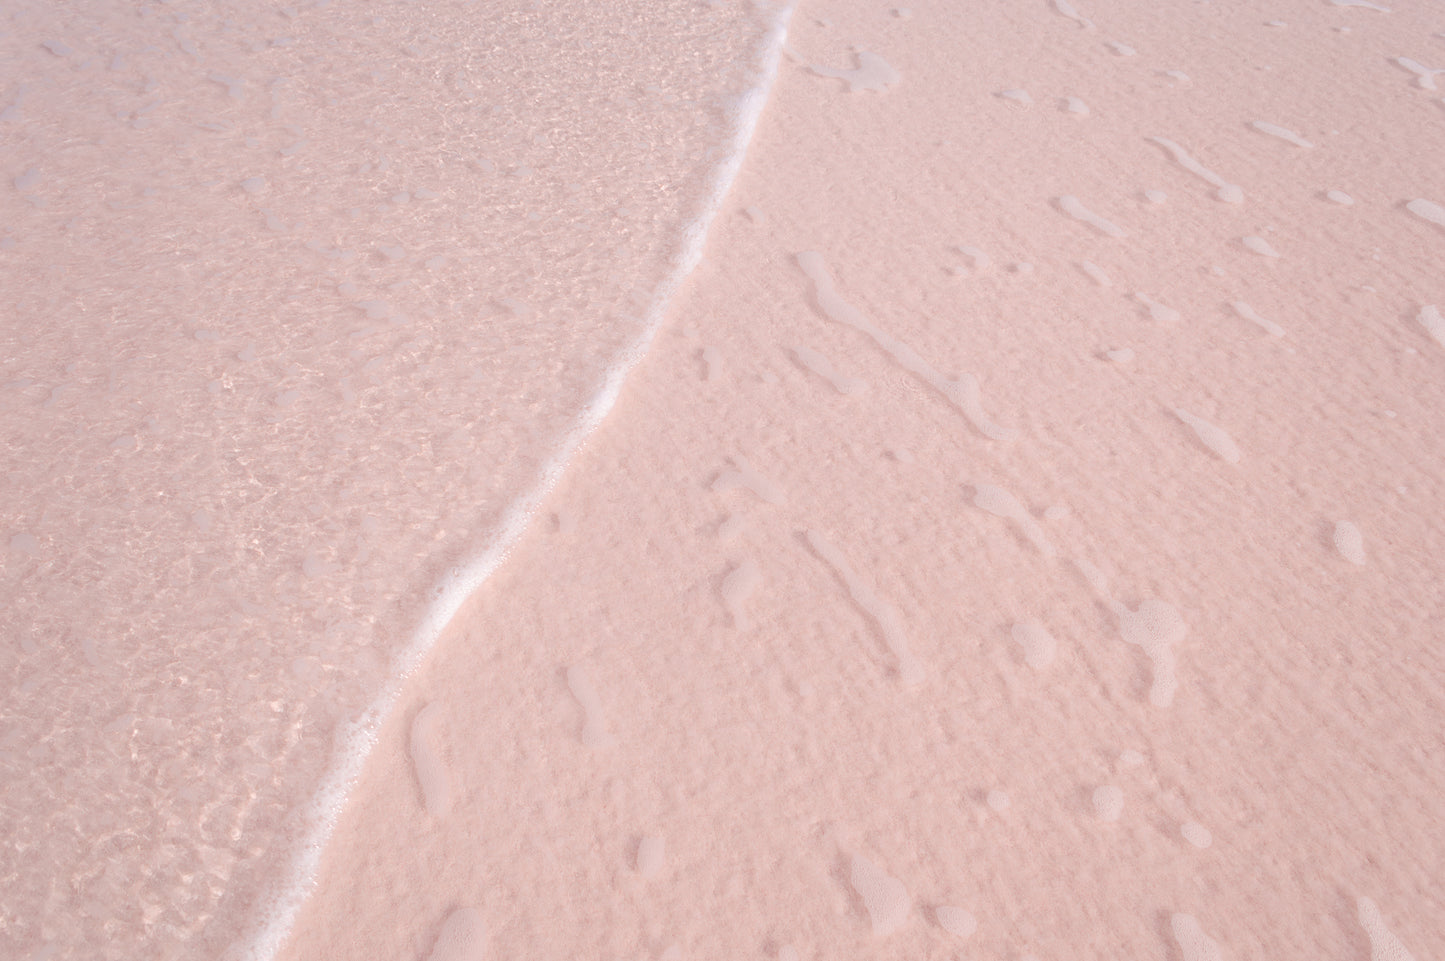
[234,1,795,961]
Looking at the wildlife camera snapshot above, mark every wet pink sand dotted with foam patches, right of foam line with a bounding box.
[6,0,1445,961]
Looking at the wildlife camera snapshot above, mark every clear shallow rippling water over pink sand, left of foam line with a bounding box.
[0,0,776,958]
